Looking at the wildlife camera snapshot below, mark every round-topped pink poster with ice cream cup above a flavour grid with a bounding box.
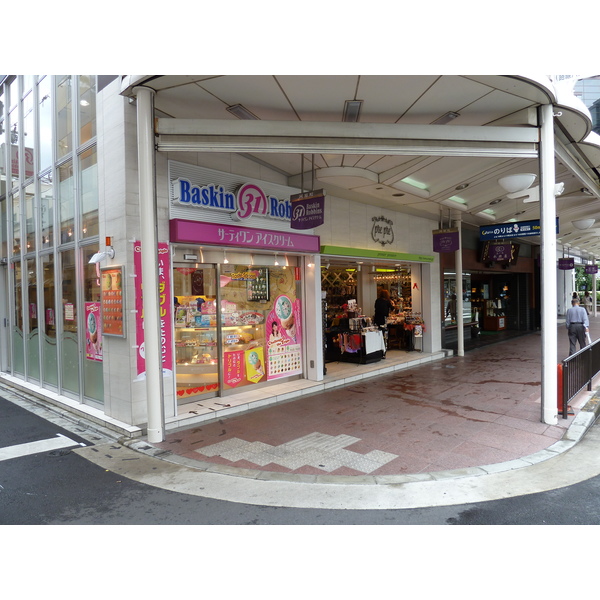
[266,294,302,380]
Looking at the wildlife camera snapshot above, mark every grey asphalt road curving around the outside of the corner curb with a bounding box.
[0,398,600,525]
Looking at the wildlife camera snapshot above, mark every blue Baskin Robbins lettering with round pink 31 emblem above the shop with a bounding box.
[173,178,292,221]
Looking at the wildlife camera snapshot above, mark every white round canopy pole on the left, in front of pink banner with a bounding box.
[134,87,165,442]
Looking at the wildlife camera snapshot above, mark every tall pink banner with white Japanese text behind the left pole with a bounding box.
[133,242,173,379]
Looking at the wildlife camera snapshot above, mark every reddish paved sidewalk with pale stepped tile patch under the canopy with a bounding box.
[144,316,600,483]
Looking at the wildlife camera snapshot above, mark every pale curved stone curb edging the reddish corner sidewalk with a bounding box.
[118,388,600,486]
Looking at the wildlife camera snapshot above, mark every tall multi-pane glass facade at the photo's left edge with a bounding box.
[0,75,104,405]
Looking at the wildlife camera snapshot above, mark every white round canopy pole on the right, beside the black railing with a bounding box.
[539,104,558,425]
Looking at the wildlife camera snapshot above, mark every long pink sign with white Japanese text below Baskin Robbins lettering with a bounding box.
[170,219,321,254]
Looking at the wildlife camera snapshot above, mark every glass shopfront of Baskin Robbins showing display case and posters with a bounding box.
[173,254,302,405]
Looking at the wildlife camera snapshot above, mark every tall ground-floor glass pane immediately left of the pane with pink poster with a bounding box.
[60,250,79,394]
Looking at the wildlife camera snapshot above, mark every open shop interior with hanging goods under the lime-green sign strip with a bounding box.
[321,257,424,364]
